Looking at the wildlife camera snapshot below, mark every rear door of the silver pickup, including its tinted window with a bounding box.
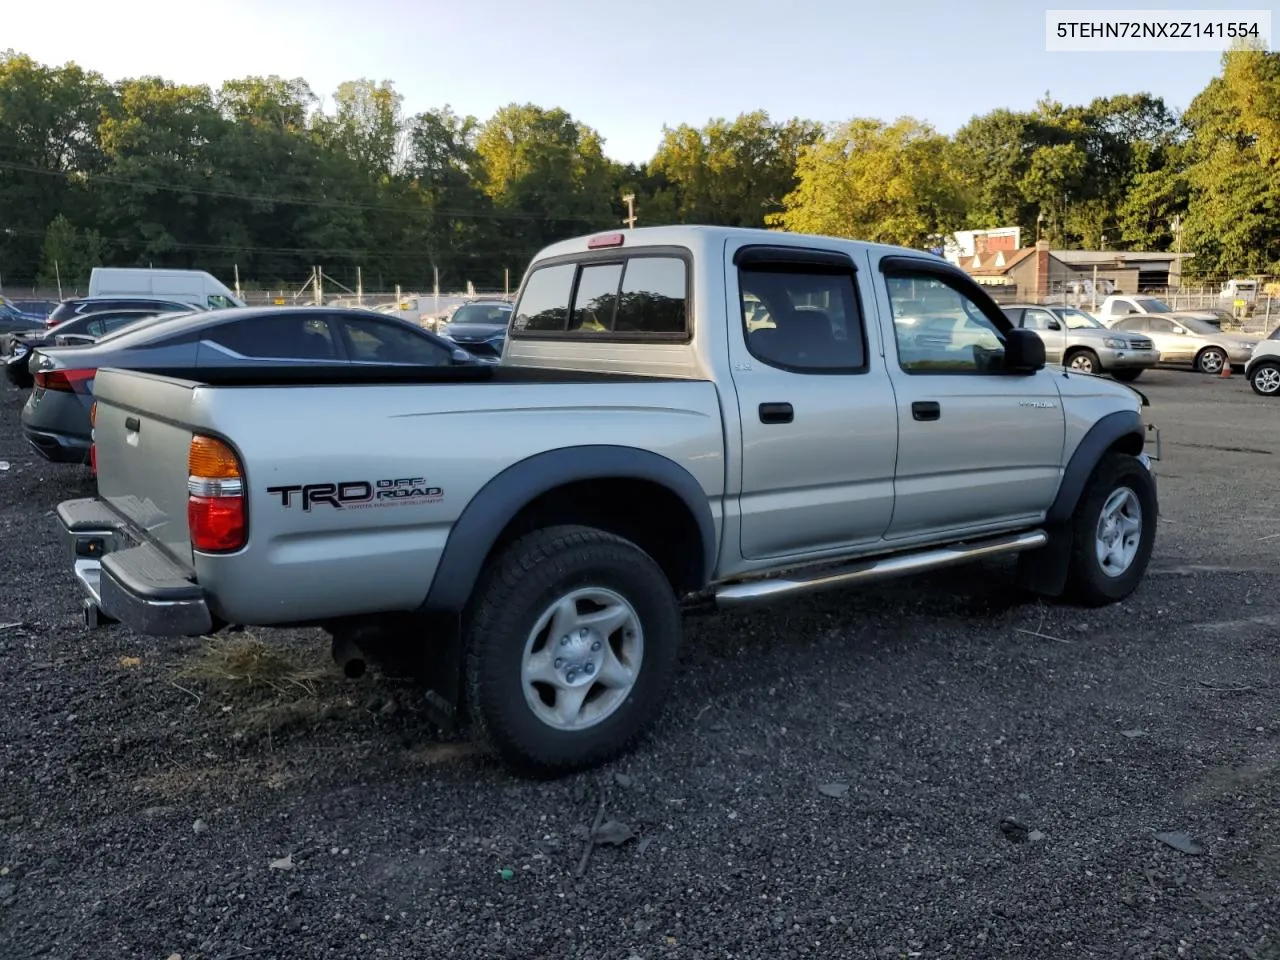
[724,243,897,559]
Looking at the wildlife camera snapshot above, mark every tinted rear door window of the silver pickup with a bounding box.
[739,266,868,374]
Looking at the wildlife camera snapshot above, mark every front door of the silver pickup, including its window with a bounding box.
[876,256,1066,540]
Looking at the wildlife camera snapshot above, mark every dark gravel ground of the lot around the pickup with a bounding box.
[0,372,1280,960]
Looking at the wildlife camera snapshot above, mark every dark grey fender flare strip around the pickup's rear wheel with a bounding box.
[421,444,717,612]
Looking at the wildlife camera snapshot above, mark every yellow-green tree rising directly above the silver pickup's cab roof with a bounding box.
[767,116,964,248]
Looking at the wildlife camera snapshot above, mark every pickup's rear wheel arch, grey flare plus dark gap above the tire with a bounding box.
[420,444,717,613]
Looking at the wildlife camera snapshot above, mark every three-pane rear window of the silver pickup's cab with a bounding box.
[511,253,690,340]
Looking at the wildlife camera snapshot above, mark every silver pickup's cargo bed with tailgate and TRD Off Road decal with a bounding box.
[93,365,726,625]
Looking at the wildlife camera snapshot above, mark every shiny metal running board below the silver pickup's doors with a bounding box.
[716,530,1048,607]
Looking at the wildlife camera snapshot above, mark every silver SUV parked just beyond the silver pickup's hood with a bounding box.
[1002,303,1160,383]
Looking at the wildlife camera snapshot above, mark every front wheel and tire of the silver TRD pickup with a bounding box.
[1068,453,1157,607]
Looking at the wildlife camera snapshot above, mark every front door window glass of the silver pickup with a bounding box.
[884,274,1005,374]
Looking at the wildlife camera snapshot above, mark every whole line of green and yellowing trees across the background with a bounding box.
[0,50,1280,289]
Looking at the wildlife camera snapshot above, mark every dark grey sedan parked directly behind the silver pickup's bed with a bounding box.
[22,307,479,463]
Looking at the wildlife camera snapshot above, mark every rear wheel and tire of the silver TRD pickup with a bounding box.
[465,526,681,776]
